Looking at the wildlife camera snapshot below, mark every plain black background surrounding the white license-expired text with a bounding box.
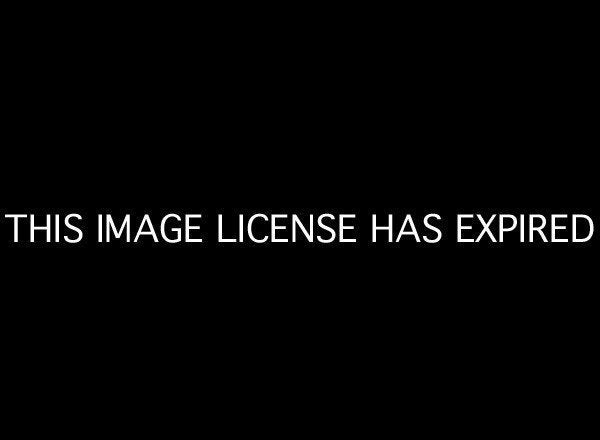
[1,5,598,433]
